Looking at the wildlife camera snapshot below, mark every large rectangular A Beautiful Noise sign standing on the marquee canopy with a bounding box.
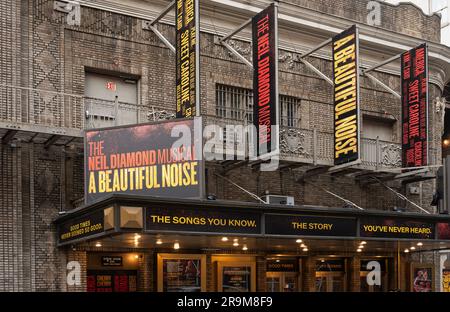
[85,119,203,203]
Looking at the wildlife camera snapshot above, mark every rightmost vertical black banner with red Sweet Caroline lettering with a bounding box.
[401,43,428,167]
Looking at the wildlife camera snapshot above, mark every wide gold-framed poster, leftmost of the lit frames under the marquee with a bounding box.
[158,254,206,292]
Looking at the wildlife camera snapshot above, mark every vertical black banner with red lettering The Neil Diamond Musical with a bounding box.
[252,4,279,156]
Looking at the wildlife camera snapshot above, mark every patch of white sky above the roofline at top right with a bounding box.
[384,0,450,46]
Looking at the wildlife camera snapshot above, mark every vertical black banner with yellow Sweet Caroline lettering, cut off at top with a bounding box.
[175,0,200,118]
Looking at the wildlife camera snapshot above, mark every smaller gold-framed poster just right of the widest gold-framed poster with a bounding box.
[217,261,256,292]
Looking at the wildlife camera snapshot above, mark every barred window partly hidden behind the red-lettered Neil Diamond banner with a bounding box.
[216,84,301,127]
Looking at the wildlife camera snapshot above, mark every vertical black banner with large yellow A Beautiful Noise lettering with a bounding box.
[333,25,361,166]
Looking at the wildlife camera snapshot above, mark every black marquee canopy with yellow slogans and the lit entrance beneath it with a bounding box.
[56,195,450,292]
